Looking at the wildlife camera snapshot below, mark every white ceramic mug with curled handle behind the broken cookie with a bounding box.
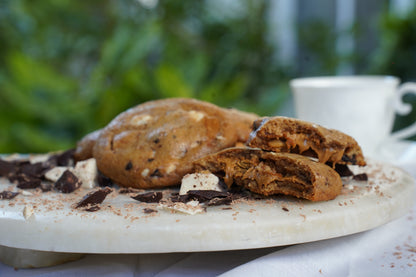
[290,76,416,156]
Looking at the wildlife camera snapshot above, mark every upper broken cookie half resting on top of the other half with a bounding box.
[247,116,366,166]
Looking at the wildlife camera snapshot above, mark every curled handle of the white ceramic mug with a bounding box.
[390,82,416,140]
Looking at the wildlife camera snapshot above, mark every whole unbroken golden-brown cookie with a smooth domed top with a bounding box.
[89,98,258,188]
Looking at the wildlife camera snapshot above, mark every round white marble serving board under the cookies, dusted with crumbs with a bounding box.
[0,162,414,253]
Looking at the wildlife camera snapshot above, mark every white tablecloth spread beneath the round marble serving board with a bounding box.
[0,143,416,277]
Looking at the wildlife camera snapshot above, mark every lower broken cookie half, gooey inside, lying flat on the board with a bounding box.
[194,147,342,201]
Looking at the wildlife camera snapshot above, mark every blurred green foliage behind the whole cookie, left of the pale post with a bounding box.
[0,0,290,153]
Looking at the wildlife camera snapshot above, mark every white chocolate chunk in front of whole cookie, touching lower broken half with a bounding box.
[179,173,224,195]
